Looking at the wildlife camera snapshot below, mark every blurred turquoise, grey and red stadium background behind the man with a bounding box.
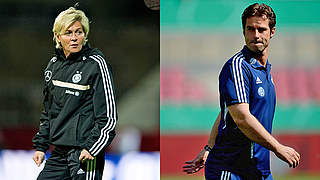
[160,0,320,180]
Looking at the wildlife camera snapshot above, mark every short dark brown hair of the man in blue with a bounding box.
[241,3,276,30]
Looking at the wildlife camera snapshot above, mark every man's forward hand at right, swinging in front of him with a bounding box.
[274,144,300,168]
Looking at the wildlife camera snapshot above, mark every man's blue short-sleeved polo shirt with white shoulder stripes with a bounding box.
[206,46,276,175]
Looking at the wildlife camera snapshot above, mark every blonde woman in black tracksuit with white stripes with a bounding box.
[32,7,117,180]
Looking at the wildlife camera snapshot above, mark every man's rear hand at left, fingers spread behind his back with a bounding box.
[183,149,209,174]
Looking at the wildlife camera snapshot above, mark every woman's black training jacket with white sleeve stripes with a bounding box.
[32,45,117,156]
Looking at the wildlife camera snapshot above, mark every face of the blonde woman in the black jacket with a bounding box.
[56,21,84,57]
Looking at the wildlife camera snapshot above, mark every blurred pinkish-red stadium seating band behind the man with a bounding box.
[160,67,320,104]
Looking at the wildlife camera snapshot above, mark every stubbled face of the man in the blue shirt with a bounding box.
[243,16,275,54]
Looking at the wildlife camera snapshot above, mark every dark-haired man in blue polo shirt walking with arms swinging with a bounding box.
[183,3,300,180]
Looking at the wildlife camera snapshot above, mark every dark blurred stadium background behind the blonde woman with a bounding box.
[0,0,160,180]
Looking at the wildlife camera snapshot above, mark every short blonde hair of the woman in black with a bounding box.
[52,7,89,48]
